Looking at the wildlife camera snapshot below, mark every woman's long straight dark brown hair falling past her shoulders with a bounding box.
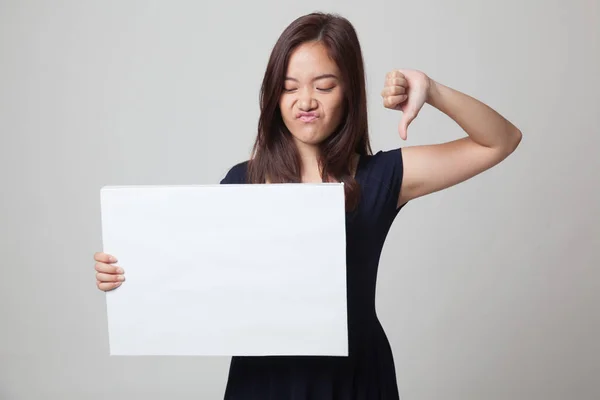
[248,13,371,210]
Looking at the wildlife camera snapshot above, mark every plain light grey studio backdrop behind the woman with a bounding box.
[0,0,600,400]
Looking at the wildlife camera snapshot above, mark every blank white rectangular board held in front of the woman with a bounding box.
[101,183,348,356]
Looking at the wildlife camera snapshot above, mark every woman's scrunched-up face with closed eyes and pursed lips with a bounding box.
[279,42,344,146]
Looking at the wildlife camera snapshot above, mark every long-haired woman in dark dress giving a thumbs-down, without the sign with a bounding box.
[95,13,521,400]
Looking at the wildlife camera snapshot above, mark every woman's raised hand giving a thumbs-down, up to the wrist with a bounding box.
[381,69,433,140]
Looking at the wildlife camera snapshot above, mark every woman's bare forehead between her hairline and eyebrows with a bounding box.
[287,42,339,79]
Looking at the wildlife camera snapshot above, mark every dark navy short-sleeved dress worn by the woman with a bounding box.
[221,149,403,400]
